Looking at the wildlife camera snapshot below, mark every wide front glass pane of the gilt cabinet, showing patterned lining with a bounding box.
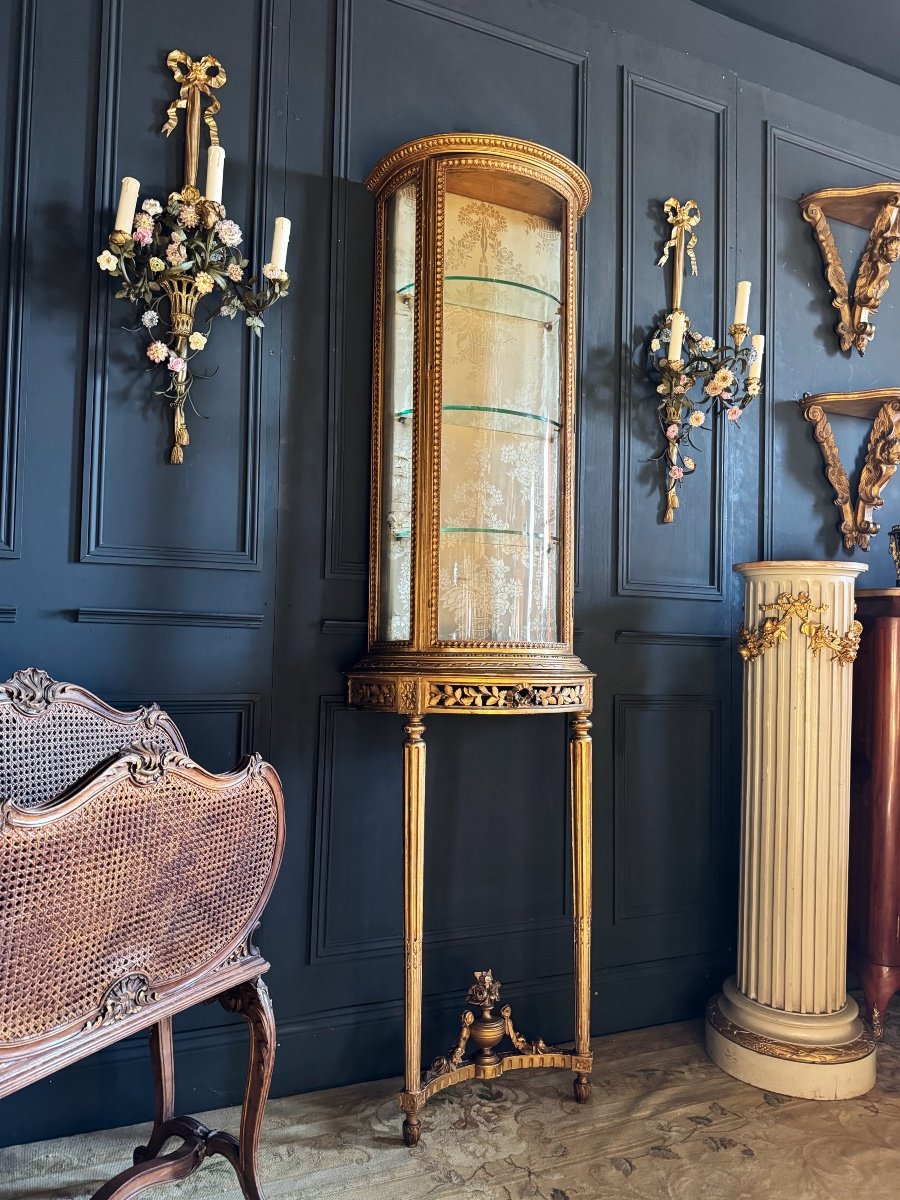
[438,172,563,642]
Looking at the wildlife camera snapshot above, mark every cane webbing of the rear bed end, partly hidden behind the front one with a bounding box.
[0,698,180,809]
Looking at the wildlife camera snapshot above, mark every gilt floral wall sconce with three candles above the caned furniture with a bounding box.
[97,50,290,463]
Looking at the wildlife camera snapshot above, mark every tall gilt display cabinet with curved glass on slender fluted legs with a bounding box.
[349,133,593,1145]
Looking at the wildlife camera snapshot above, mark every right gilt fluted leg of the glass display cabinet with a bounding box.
[569,713,593,1104]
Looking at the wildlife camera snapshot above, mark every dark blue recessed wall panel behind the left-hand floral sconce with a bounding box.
[82,0,271,569]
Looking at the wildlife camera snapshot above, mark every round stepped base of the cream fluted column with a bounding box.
[706,979,876,1100]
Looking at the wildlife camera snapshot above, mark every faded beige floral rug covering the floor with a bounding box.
[0,1006,900,1200]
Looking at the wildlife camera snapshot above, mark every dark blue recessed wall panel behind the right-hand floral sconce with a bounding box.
[619,70,733,600]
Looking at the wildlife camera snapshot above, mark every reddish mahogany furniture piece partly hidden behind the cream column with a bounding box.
[850,588,900,1038]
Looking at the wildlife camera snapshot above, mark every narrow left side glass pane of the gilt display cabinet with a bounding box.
[378,182,416,642]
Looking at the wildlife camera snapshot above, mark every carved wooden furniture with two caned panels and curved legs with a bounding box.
[0,668,284,1200]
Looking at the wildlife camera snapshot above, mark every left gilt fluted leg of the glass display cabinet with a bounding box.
[400,716,425,1146]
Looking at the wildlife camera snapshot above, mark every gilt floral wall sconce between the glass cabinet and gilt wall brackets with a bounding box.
[647,196,766,524]
